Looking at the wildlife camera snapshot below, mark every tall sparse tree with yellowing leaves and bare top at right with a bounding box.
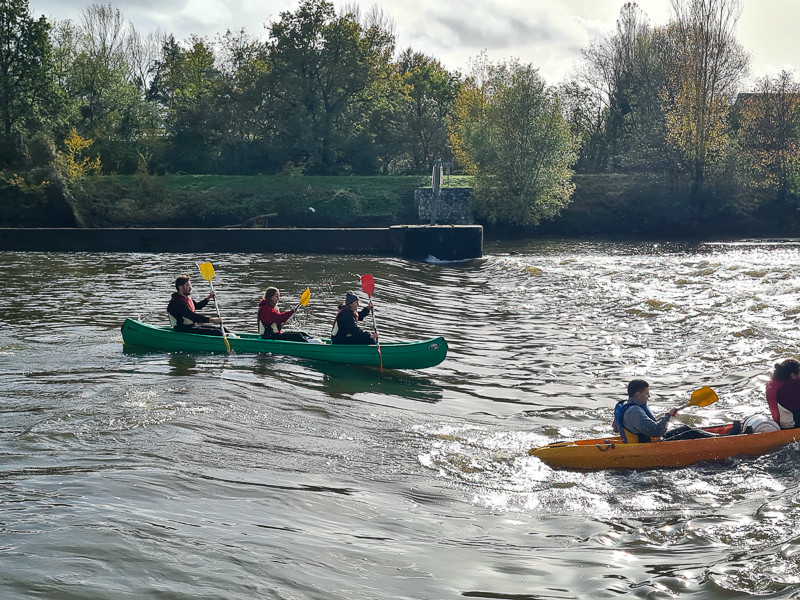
[665,0,749,203]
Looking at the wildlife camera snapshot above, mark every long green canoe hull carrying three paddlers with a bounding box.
[122,319,454,369]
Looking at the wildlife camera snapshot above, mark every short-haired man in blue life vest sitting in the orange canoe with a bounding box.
[613,379,724,444]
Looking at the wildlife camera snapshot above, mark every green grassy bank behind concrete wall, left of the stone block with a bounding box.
[73,175,472,227]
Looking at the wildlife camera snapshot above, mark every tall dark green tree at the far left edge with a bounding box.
[0,0,56,165]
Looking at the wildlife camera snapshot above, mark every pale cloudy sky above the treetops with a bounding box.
[29,0,800,84]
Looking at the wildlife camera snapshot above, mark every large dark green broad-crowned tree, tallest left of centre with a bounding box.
[269,0,394,174]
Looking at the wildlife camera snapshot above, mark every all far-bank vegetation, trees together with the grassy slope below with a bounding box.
[0,0,800,234]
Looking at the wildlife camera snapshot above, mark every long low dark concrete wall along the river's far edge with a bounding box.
[0,225,483,260]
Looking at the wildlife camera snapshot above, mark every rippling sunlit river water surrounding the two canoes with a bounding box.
[0,241,800,600]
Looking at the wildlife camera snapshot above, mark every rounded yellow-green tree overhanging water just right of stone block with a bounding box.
[454,57,576,225]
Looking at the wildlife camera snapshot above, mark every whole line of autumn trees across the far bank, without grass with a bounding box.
[0,0,800,225]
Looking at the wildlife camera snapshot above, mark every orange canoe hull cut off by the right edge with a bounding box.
[528,424,800,471]
